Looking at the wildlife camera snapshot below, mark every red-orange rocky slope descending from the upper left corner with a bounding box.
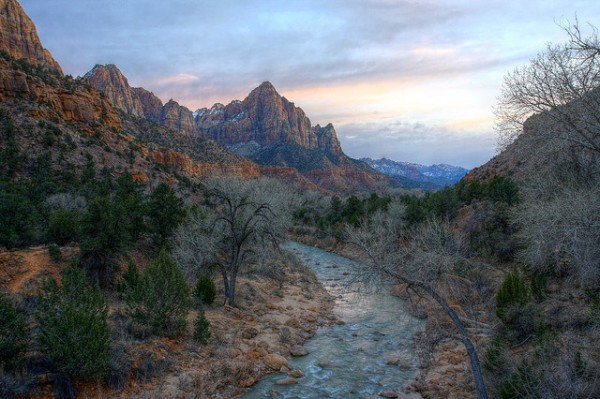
[0,0,260,190]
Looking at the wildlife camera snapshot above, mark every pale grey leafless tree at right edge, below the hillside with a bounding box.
[513,175,600,288]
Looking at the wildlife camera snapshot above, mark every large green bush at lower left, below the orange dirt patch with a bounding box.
[35,262,111,379]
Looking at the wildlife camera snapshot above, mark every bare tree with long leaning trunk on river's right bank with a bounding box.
[347,213,488,399]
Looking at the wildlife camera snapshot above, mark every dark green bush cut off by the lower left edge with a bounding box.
[0,293,29,371]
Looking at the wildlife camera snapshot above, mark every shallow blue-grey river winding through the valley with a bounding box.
[243,242,423,399]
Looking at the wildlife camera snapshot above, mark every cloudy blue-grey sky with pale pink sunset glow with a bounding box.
[20,0,600,168]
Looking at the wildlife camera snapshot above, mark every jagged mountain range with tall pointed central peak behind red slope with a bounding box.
[84,65,387,191]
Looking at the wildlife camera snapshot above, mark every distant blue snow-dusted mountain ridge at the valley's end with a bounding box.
[360,158,469,189]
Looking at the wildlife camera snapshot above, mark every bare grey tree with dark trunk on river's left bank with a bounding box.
[174,178,290,306]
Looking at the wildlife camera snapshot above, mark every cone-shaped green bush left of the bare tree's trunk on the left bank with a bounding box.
[125,249,191,336]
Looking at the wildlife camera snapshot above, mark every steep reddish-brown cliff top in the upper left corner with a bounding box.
[0,0,63,75]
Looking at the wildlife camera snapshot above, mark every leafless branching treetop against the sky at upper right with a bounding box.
[495,21,600,163]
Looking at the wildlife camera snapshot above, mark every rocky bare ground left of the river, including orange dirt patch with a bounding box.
[0,247,335,399]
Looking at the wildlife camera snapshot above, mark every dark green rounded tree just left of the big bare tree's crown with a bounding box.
[147,183,186,247]
